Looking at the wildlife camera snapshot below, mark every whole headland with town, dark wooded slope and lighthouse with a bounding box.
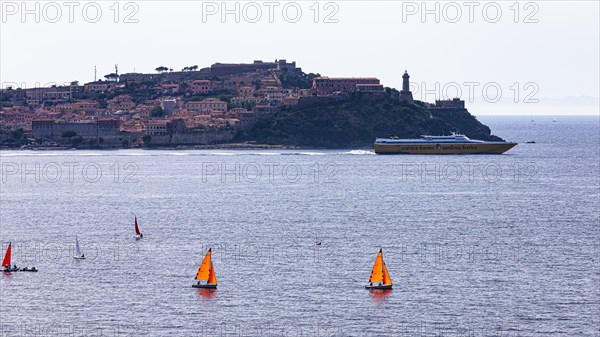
[0,60,501,149]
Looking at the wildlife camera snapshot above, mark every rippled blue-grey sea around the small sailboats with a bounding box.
[0,116,600,337]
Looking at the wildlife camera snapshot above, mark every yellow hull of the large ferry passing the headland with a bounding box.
[375,143,517,154]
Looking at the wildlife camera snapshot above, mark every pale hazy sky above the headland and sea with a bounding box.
[0,1,600,113]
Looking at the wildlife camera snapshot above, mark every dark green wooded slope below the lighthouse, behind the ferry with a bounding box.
[242,94,501,147]
